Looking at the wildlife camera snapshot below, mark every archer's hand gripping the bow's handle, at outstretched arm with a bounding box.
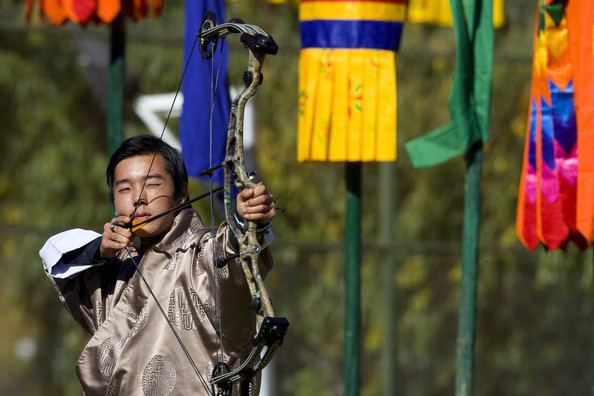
[236,184,276,224]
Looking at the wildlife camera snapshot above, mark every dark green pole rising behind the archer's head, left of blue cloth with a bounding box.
[106,14,126,156]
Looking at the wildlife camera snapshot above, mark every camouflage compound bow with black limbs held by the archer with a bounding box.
[199,15,289,389]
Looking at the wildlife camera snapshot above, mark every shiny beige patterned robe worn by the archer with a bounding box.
[52,209,271,396]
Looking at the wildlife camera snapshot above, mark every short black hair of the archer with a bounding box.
[105,135,188,204]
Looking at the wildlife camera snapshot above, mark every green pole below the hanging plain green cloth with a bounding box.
[456,144,483,396]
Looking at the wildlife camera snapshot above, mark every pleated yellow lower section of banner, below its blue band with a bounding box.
[297,48,396,161]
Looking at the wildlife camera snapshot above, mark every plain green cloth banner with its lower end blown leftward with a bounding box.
[406,0,493,167]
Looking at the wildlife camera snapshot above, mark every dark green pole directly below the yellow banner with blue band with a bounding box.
[344,162,361,396]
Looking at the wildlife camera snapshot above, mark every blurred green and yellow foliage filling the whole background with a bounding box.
[0,0,592,396]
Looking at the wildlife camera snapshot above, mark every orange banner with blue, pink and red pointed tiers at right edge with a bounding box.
[516,0,594,250]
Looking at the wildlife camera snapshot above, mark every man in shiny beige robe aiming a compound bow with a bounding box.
[40,136,275,396]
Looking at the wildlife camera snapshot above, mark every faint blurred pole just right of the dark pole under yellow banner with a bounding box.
[379,162,396,396]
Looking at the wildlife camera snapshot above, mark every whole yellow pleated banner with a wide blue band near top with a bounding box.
[297,0,407,161]
